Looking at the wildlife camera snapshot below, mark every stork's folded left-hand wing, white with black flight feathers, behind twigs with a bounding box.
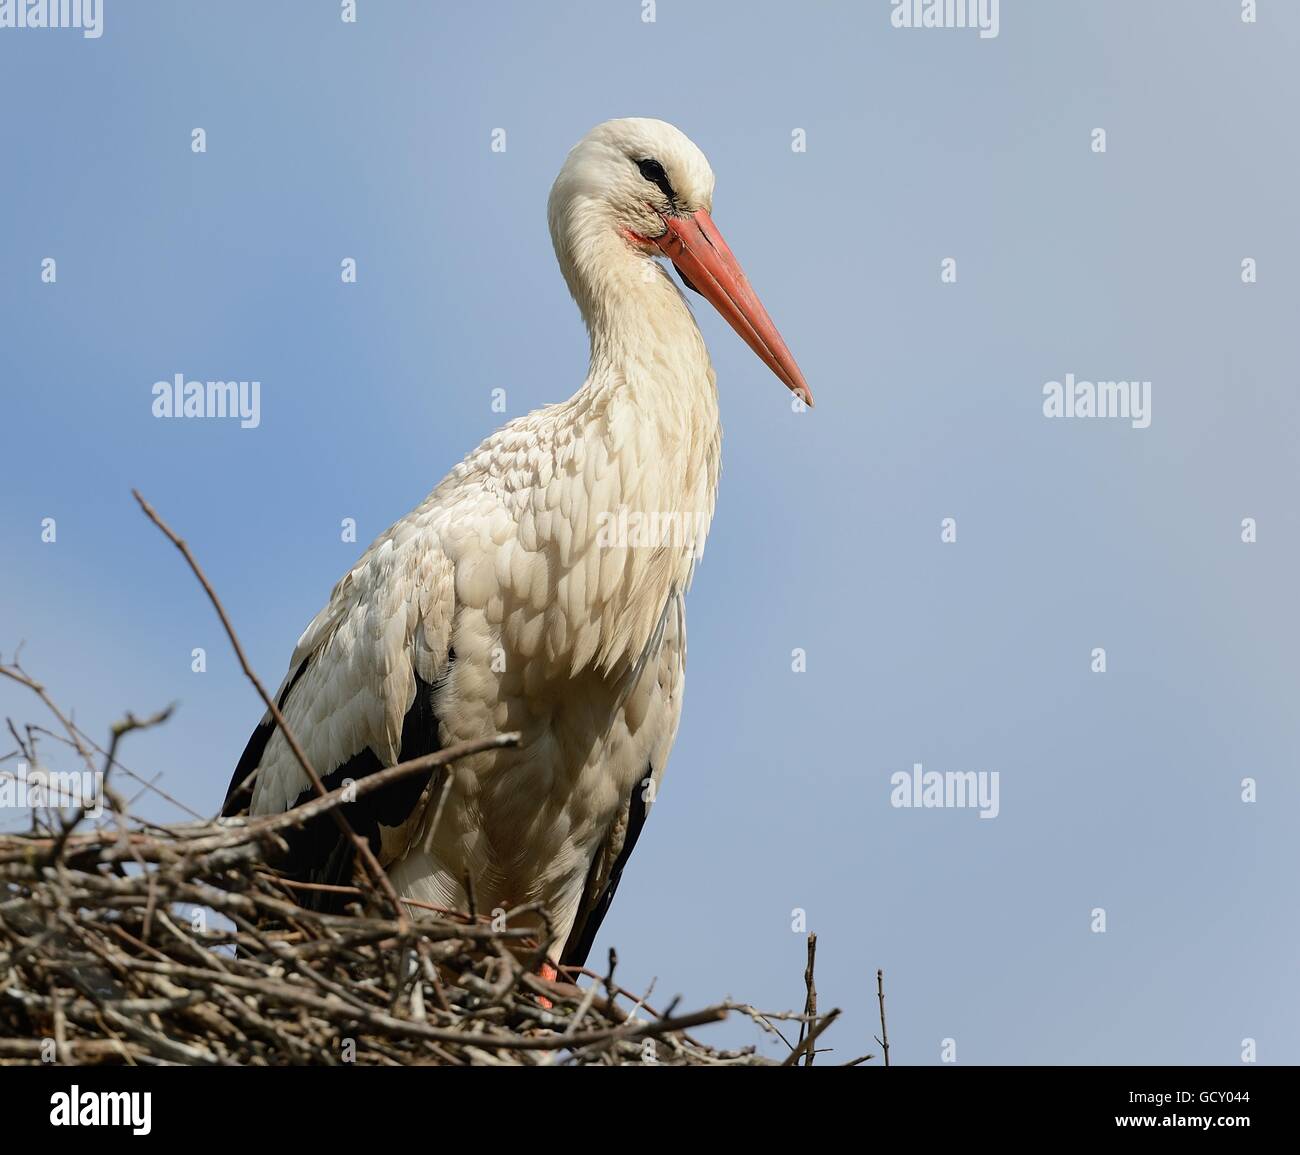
[222,507,455,905]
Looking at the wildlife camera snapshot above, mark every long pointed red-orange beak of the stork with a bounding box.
[653,209,813,406]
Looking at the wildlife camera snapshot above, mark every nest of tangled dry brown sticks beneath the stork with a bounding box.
[0,494,847,1065]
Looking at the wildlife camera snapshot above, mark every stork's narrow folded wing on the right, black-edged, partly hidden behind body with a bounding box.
[560,592,686,966]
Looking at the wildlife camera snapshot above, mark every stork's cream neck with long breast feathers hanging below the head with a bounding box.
[533,223,722,670]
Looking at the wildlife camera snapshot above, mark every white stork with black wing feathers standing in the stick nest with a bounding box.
[225,120,811,978]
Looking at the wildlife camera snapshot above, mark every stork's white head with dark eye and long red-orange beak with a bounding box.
[547,117,813,405]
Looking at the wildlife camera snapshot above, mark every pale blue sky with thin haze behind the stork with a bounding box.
[0,0,1300,1064]
